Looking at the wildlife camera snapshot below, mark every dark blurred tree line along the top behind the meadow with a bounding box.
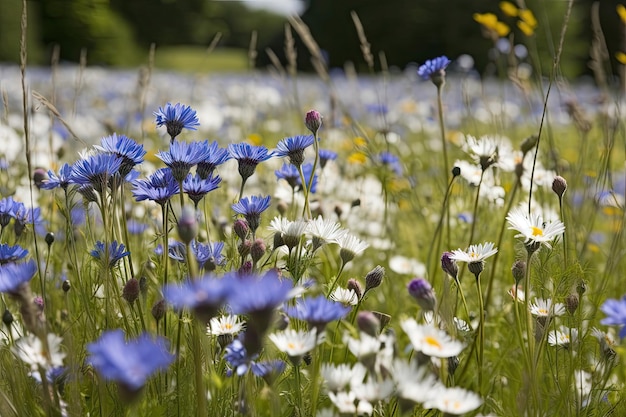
[0,0,626,76]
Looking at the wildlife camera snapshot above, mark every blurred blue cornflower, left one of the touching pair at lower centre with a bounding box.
[163,275,232,323]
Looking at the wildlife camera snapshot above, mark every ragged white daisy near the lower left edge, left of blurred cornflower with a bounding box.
[11,333,65,371]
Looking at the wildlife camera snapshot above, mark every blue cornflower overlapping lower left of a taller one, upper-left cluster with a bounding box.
[70,153,122,193]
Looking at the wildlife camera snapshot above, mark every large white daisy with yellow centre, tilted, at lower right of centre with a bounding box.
[400,319,464,358]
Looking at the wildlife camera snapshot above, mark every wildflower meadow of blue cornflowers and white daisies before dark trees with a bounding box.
[0,2,626,417]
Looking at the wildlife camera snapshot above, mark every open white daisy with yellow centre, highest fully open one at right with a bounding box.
[506,207,565,248]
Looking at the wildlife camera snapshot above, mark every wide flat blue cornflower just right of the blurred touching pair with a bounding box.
[285,295,350,334]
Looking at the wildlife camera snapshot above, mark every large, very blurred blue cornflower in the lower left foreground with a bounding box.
[87,329,174,394]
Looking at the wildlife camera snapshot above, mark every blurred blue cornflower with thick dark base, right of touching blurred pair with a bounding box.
[225,270,293,353]
